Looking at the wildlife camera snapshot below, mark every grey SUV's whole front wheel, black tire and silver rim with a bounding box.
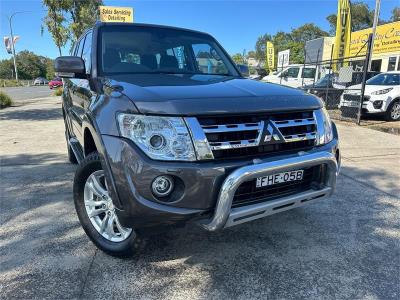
[74,152,140,257]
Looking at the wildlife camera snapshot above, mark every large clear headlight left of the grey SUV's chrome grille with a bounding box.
[118,113,196,161]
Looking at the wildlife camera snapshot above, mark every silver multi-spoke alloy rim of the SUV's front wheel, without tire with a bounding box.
[84,170,132,242]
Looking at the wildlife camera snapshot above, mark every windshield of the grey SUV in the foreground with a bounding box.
[99,26,239,76]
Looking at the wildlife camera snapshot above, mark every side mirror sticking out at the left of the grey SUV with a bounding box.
[54,56,87,79]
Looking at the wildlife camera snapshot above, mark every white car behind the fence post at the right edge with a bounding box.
[339,71,400,121]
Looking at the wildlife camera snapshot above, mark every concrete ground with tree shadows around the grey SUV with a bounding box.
[0,97,400,299]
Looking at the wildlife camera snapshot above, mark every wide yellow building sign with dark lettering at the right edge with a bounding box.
[350,21,400,56]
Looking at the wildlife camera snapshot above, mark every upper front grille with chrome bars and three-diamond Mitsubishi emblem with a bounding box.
[197,111,317,159]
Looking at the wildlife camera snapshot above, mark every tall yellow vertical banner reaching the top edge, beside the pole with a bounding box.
[333,0,351,59]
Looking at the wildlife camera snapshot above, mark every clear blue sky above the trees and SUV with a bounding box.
[0,0,400,59]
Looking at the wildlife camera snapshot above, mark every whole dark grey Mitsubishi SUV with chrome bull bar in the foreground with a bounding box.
[55,23,340,256]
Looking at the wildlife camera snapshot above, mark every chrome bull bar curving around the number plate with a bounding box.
[201,151,338,231]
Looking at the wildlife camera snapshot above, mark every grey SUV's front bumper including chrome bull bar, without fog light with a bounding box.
[102,134,340,230]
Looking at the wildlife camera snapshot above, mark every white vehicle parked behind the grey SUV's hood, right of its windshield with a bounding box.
[262,65,317,88]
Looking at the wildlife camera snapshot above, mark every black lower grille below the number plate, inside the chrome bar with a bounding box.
[232,166,325,207]
